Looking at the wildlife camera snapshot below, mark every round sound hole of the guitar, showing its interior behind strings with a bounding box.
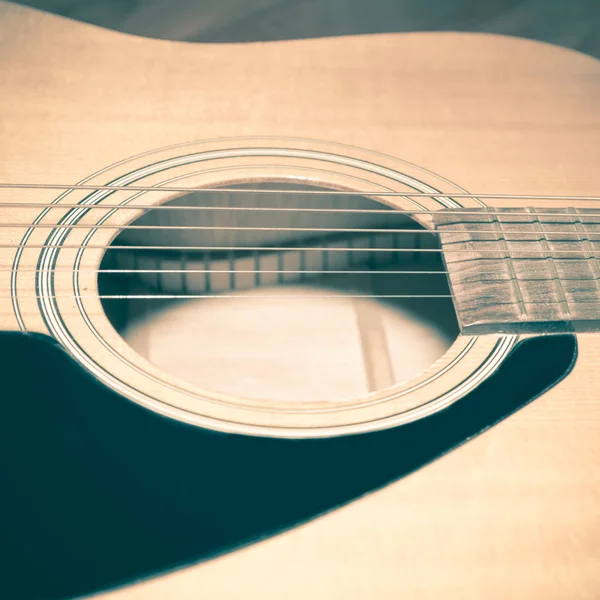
[99,183,458,402]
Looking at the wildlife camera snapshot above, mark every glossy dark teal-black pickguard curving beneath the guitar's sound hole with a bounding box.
[0,333,576,600]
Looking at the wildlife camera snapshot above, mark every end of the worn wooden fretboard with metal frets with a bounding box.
[434,208,600,334]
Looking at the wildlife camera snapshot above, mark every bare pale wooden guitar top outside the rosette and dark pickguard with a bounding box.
[0,3,600,599]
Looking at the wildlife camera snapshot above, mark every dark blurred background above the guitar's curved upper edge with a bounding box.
[12,0,600,56]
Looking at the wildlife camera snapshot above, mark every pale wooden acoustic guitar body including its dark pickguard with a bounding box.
[0,2,600,600]
